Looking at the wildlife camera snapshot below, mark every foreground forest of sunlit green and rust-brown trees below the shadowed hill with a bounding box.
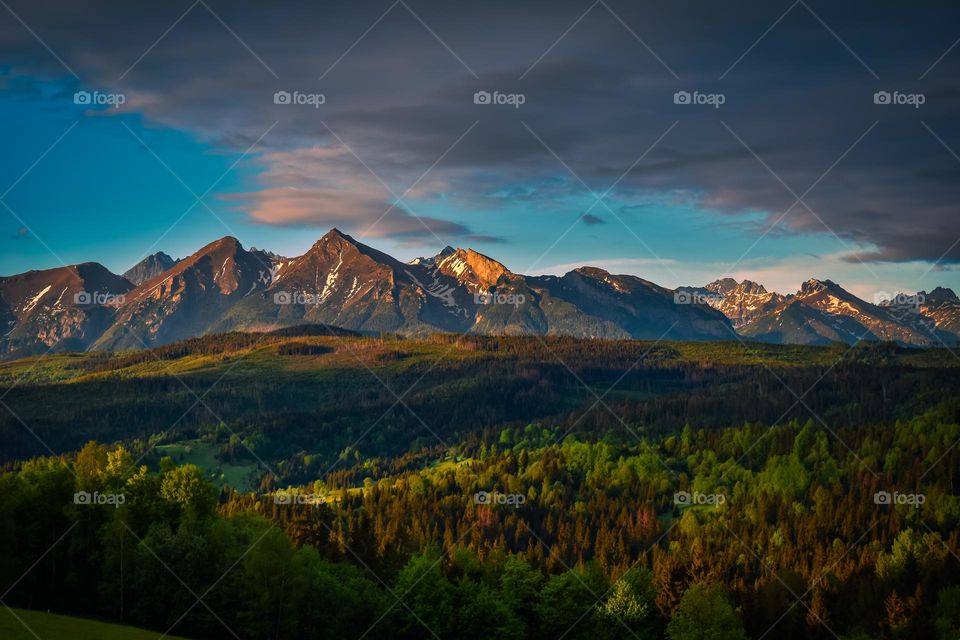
[0,406,960,640]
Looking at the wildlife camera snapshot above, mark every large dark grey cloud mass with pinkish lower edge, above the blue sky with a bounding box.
[0,0,960,262]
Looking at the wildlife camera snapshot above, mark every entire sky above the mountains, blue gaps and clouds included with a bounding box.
[0,0,960,297]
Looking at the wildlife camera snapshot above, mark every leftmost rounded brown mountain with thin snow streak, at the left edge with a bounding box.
[0,262,133,357]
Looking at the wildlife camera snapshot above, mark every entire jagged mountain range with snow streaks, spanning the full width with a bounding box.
[0,229,960,358]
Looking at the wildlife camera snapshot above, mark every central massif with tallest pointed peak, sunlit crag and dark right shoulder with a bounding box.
[217,229,730,340]
